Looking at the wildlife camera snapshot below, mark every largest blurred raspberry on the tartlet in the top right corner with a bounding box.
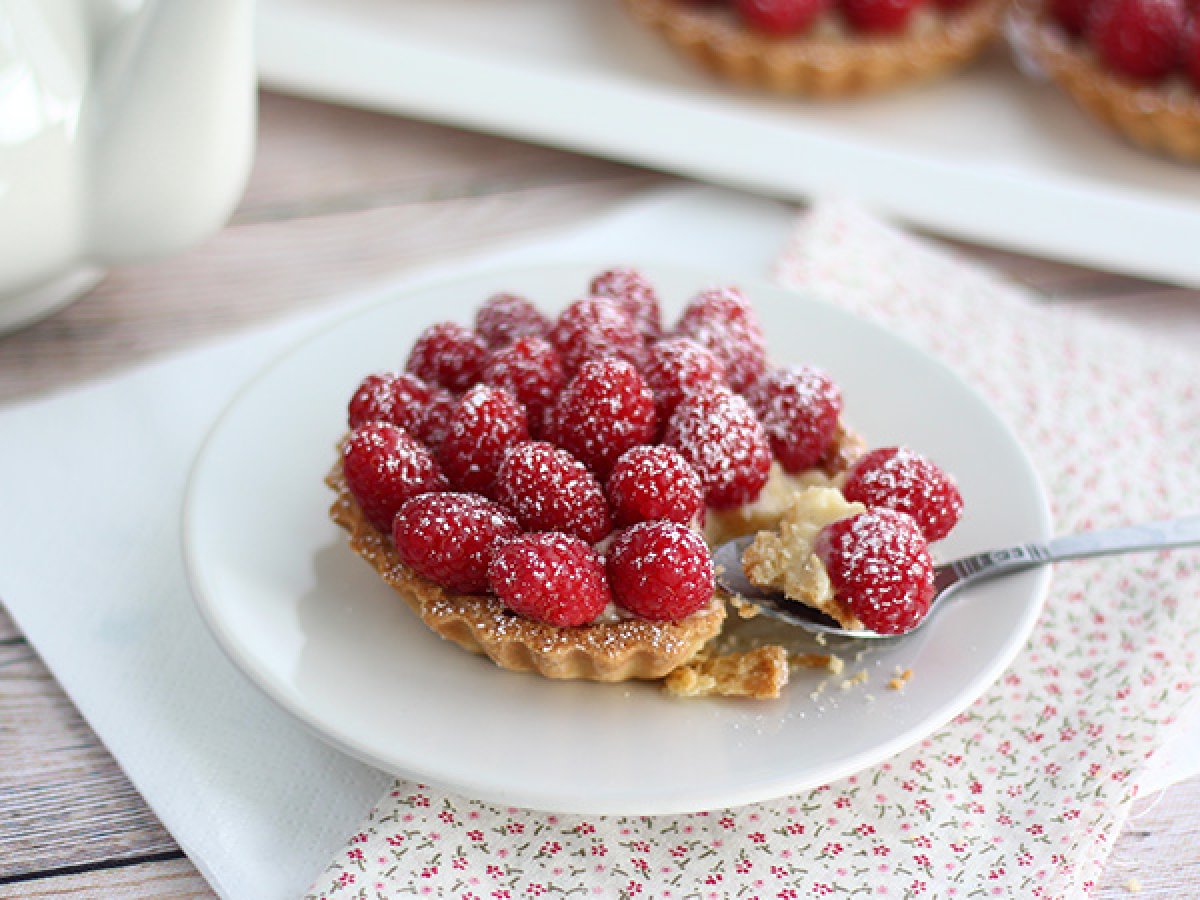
[1087,0,1186,82]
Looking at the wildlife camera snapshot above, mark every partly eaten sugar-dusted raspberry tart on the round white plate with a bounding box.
[326,269,946,698]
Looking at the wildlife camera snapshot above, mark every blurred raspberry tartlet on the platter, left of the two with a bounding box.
[625,0,1006,97]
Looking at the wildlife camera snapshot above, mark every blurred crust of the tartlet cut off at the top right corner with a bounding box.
[1009,0,1200,162]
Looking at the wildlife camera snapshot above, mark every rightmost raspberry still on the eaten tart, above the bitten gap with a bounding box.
[746,366,841,473]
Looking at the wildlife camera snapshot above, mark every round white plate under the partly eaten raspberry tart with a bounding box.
[184,265,1050,815]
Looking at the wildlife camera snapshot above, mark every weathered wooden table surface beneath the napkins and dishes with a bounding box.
[0,94,1200,898]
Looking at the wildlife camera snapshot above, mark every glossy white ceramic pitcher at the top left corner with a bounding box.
[0,0,254,332]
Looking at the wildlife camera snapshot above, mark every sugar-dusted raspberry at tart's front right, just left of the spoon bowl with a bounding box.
[608,522,715,622]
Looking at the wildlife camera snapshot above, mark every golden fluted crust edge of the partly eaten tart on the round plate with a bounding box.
[325,463,725,682]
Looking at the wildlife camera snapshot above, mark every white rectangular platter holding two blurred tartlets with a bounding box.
[257,0,1200,287]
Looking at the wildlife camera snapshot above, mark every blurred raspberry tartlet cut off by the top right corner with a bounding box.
[1009,0,1200,162]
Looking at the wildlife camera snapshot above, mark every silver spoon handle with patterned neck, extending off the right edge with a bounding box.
[938,515,1200,588]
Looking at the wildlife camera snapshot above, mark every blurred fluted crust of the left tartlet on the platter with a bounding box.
[625,0,1007,97]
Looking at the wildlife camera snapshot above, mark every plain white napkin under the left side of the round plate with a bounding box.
[0,188,792,900]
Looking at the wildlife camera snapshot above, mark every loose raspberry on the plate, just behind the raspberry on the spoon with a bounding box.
[841,446,962,541]
